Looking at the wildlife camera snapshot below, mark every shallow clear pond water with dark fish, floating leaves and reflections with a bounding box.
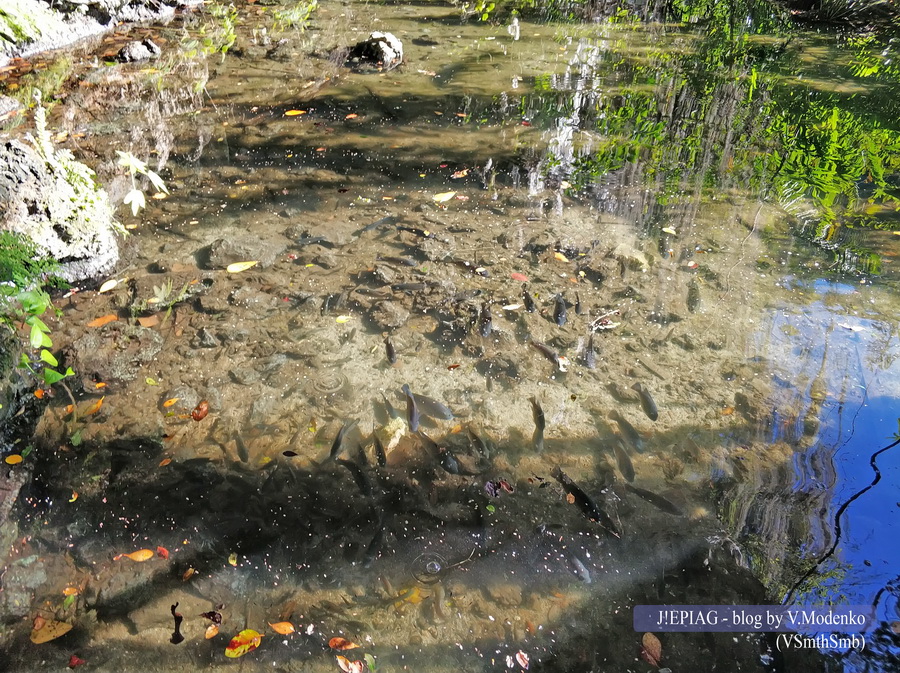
[0,2,900,672]
